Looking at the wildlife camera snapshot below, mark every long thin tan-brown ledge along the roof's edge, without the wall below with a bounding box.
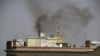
[5,47,93,52]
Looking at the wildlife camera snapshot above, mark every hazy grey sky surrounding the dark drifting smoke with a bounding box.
[0,0,100,56]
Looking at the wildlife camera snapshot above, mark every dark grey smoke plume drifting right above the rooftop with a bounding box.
[35,5,92,35]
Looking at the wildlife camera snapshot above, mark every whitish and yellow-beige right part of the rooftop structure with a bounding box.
[41,35,65,47]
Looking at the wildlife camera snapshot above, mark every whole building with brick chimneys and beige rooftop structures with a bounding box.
[5,35,98,56]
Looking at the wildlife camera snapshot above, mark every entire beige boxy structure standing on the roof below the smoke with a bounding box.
[27,35,65,47]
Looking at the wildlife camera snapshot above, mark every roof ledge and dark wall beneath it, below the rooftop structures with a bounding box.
[6,47,93,56]
